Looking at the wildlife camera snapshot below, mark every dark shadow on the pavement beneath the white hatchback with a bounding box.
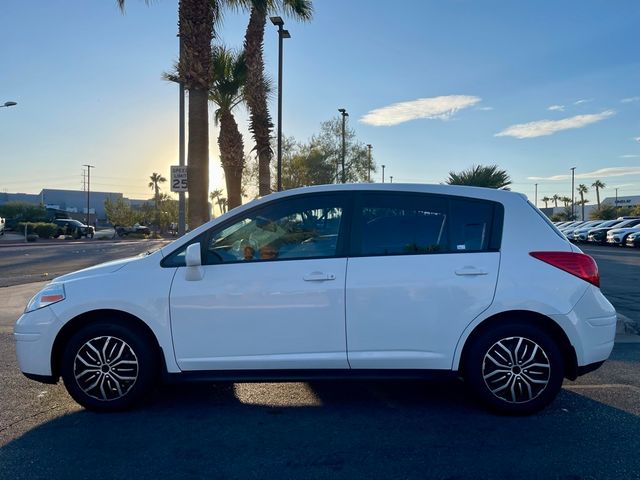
[0,381,640,480]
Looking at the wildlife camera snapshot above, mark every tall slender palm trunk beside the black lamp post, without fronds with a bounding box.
[244,8,273,196]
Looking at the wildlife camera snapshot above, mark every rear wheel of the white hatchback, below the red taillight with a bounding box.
[464,323,564,415]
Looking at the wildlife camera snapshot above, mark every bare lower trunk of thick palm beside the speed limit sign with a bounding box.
[187,88,209,230]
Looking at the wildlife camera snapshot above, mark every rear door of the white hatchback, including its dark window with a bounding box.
[346,192,503,369]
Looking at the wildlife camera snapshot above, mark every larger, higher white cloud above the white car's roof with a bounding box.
[360,95,481,127]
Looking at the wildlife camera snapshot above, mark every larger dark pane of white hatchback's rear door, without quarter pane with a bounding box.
[354,194,448,255]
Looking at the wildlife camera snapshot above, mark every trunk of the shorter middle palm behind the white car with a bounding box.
[218,110,244,210]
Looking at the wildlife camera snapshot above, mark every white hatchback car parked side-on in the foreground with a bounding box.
[15,184,616,413]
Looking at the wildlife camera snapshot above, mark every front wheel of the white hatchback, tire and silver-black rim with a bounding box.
[60,322,159,412]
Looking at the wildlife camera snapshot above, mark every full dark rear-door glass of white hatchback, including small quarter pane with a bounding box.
[352,193,503,256]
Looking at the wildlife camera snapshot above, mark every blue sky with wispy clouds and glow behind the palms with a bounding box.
[0,0,640,205]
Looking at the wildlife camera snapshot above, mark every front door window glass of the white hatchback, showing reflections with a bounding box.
[203,195,343,265]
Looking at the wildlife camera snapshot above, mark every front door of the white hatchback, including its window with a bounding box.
[170,195,348,370]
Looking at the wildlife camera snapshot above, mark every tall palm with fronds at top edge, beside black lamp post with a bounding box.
[238,0,313,196]
